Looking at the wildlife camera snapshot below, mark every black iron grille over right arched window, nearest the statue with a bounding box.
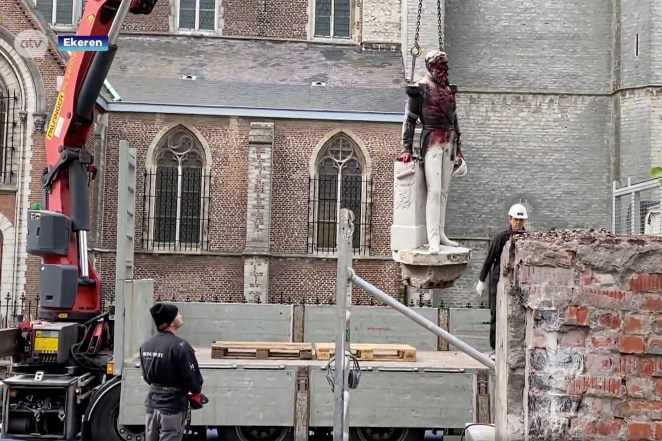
[308,175,372,255]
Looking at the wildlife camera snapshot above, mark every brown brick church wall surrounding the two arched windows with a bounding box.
[95,114,410,304]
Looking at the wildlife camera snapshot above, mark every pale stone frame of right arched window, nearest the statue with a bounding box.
[307,129,373,257]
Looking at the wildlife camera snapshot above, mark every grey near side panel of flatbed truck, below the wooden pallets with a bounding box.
[119,346,489,441]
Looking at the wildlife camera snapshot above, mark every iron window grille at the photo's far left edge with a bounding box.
[0,90,18,184]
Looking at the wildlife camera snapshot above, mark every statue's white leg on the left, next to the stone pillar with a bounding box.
[424,145,444,253]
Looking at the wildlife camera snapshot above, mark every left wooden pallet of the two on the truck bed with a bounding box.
[211,341,313,360]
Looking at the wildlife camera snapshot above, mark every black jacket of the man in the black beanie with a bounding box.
[140,332,203,412]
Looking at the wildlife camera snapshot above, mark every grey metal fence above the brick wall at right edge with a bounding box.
[612,178,662,236]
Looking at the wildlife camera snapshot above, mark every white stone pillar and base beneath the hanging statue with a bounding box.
[391,161,471,289]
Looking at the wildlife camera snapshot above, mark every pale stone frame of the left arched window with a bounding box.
[142,122,213,254]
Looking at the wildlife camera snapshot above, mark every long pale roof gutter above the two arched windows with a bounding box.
[97,97,403,123]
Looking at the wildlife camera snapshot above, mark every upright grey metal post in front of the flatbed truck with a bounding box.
[333,208,354,441]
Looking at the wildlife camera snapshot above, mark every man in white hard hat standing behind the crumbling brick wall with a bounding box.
[476,204,529,359]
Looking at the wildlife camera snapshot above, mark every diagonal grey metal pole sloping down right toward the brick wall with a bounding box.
[348,268,496,372]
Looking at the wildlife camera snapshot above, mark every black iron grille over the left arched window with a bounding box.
[142,166,211,251]
